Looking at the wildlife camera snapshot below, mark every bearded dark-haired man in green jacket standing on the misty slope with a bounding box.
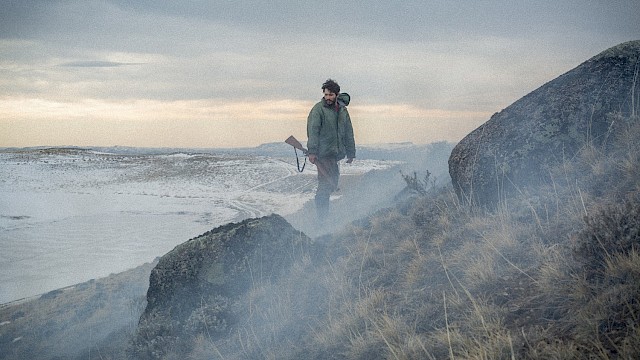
[307,79,356,221]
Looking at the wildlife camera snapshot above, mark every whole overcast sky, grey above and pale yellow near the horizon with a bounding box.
[0,0,640,148]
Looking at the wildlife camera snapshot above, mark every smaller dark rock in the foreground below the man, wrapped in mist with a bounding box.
[131,215,309,359]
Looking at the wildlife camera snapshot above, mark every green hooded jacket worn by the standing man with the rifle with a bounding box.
[307,93,356,160]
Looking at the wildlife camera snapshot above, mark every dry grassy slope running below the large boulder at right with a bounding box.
[181,119,640,359]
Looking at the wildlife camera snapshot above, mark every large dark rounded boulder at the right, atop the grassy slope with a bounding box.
[449,41,640,207]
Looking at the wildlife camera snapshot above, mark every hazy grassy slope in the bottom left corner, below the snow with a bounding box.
[0,263,155,359]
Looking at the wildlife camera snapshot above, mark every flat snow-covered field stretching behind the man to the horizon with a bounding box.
[0,148,394,304]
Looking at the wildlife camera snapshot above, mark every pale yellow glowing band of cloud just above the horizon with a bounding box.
[0,98,489,147]
